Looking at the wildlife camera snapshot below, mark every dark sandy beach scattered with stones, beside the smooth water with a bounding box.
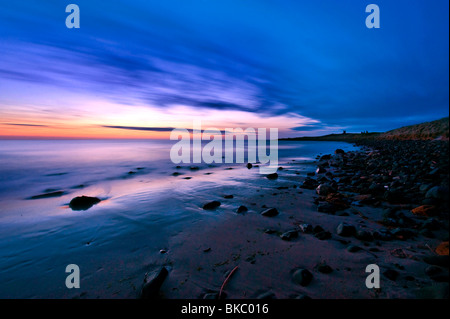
[139,142,448,299]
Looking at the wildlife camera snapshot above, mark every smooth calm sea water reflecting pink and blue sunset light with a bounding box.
[0,140,355,298]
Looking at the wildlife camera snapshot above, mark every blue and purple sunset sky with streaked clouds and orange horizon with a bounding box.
[0,0,449,138]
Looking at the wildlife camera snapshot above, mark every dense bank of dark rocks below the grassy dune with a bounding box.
[300,141,449,237]
